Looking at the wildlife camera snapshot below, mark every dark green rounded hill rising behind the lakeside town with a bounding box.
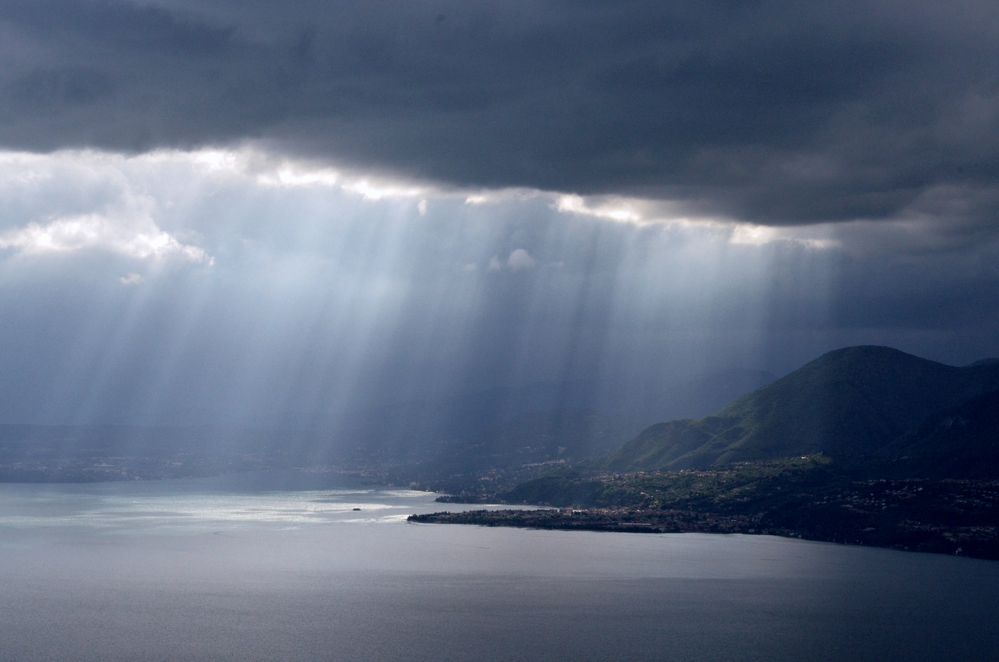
[607,346,999,478]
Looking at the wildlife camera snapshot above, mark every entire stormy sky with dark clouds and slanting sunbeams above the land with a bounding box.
[0,0,999,422]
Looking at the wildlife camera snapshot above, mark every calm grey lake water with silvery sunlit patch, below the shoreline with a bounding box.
[0,481,999,660]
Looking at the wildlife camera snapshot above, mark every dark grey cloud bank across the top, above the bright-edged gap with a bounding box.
[0,0,999,228]
